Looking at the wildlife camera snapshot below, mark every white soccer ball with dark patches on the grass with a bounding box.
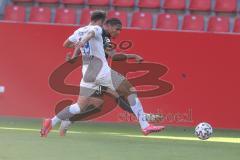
[195,122,213,140]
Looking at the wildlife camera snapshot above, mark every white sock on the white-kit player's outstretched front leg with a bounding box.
[129,95,149,129]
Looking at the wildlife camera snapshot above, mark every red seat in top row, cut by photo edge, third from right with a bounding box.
[163,0,186,10]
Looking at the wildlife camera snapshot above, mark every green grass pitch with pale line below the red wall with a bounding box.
[0,118,240,160]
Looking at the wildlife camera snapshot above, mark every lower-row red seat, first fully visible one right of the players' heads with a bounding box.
[131,12,152,29]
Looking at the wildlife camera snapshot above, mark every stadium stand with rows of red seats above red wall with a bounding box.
[0,0,240,32]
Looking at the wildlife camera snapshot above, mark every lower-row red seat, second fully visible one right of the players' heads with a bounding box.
[156,13,178,30]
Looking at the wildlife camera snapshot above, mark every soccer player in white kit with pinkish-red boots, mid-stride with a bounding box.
[40,11,164,137]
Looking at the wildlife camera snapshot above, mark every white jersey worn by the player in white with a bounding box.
[68,25,110,77]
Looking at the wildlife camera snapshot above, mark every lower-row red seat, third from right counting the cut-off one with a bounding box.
[182,15,204,31]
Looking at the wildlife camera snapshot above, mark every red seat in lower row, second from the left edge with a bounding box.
[29,7,51,23]
